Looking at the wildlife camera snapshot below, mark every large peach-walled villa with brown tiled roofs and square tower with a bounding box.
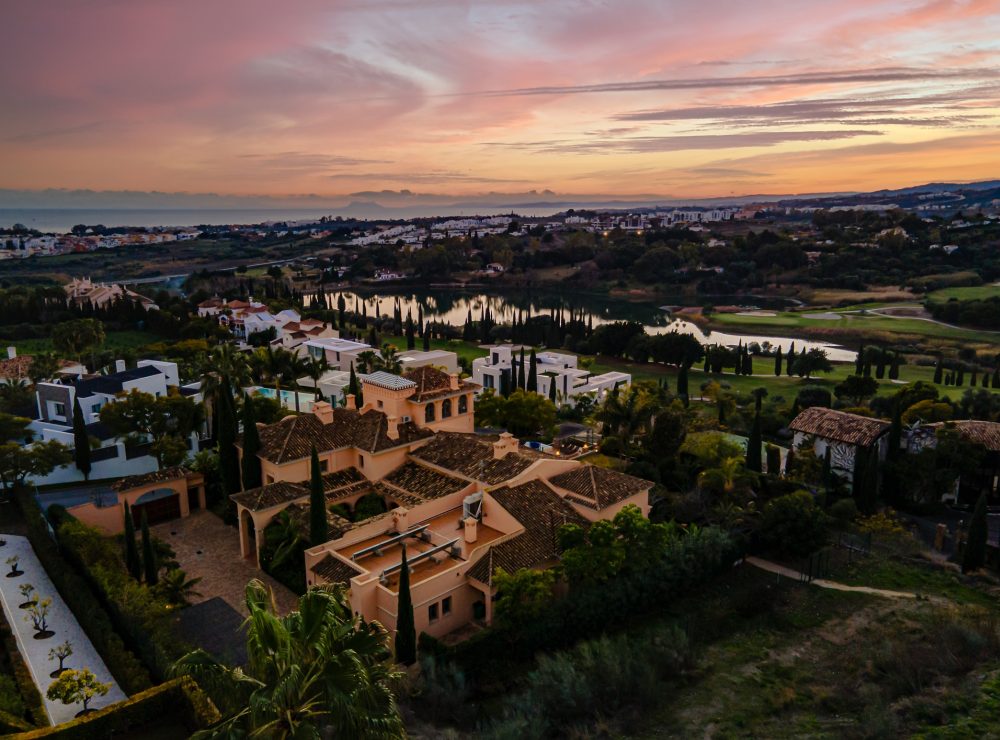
[231,368,653,637]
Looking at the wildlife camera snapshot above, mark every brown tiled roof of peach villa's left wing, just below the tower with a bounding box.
[250,408,433,465]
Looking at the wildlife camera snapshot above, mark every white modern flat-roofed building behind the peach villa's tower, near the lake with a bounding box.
[472,344,632,404]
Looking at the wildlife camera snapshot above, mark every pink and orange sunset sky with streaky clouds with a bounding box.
[0,0,1000,202]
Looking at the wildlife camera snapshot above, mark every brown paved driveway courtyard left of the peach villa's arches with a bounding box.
[149,511,298,615]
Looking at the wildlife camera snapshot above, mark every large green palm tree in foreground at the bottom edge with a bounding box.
[172,580,405,738]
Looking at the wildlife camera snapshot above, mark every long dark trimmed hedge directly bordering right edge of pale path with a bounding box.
[15,488,152,694]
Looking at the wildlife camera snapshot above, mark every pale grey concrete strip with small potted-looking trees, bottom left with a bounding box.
[0,534,128,725]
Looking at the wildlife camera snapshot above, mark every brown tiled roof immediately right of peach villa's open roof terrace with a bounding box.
[468,480,589,585]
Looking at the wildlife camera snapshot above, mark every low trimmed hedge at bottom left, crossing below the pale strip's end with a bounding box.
[18,676,222,740]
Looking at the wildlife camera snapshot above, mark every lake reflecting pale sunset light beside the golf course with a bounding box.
[306,288,856,362]
